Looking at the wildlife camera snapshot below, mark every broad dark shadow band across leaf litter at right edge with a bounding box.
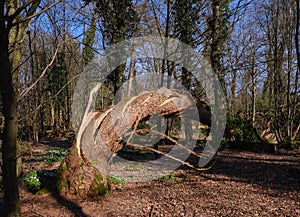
[192,150,300,191]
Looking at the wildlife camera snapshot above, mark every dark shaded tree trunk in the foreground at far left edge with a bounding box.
[0,16,20,216]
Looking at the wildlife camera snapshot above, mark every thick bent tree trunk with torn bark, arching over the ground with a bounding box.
[57,88,210,197]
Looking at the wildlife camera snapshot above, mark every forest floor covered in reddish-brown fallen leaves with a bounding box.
[0,139,300,217]
